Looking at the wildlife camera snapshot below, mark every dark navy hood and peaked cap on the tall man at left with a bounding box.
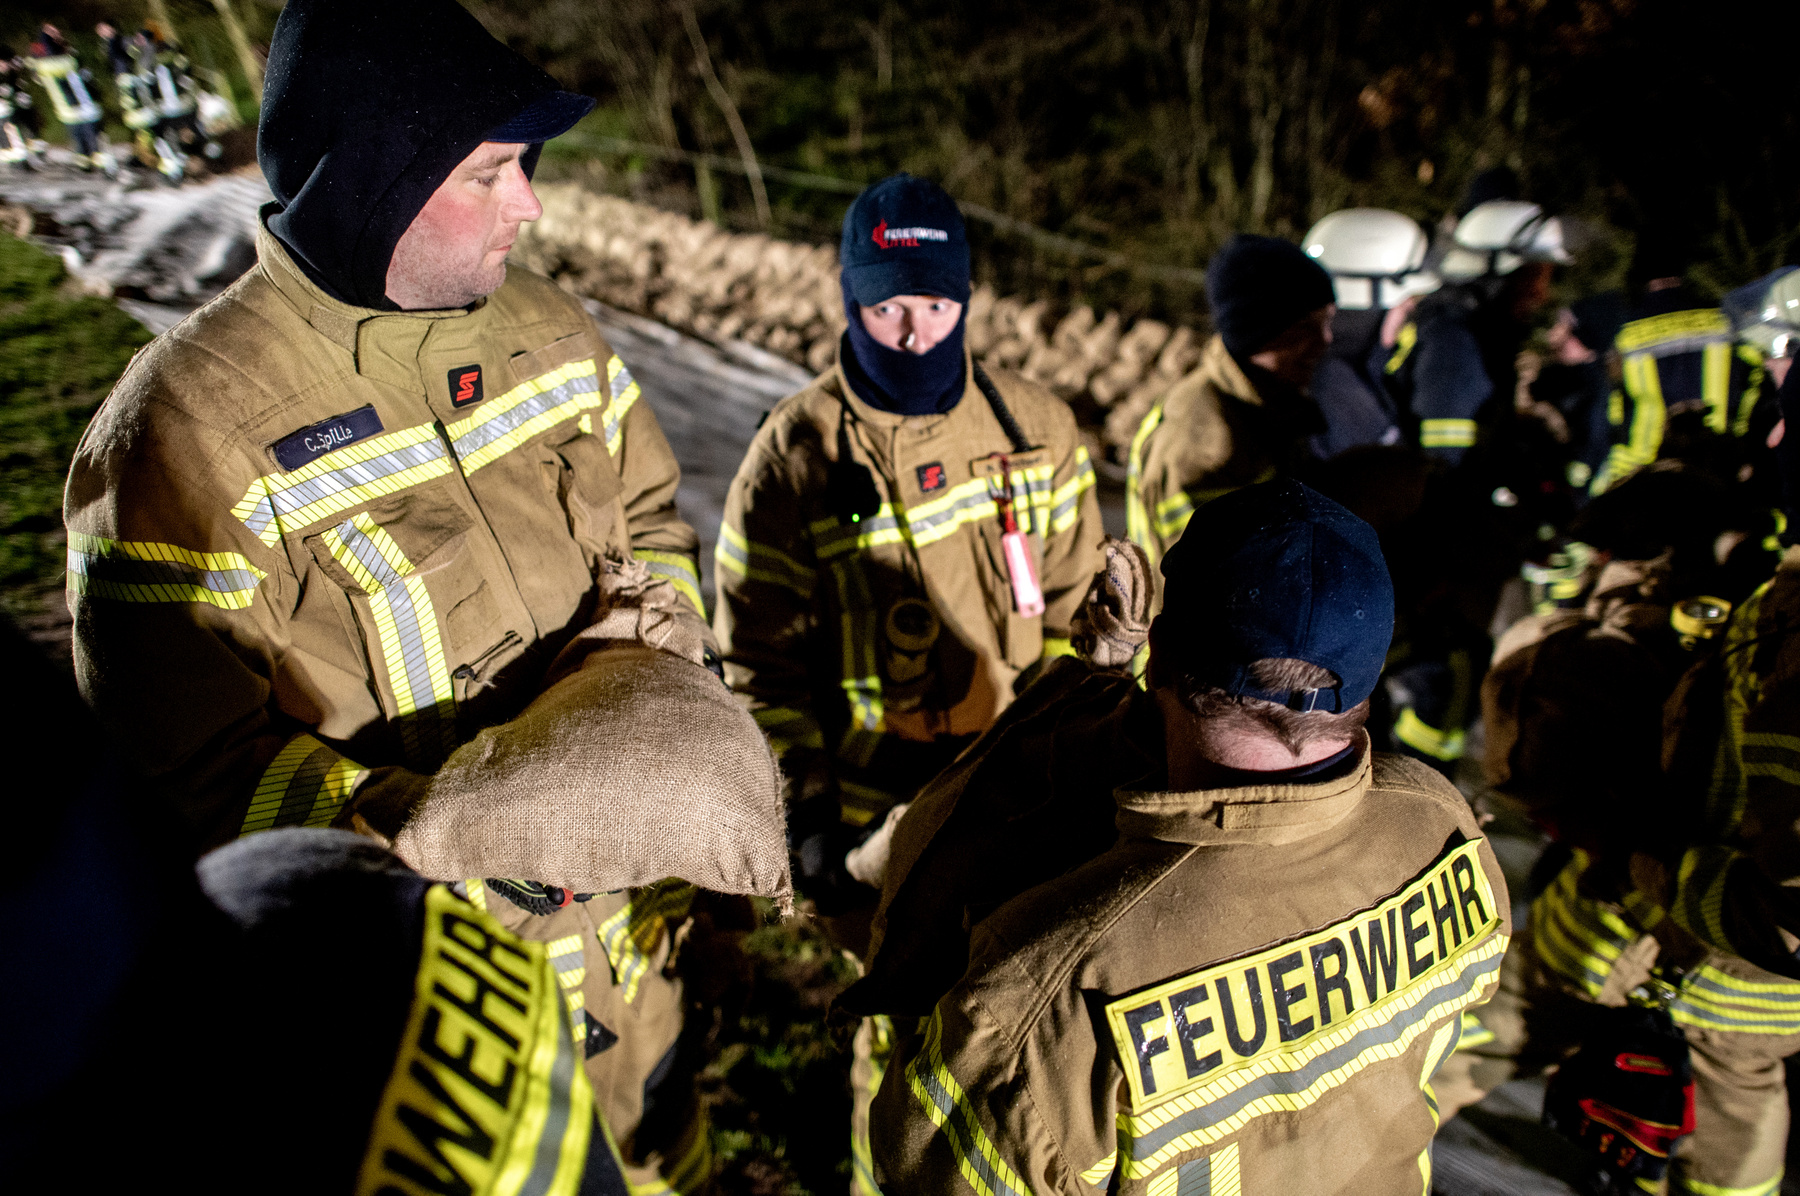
[256,0,592,312]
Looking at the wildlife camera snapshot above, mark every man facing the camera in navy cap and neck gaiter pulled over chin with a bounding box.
[715,175,1103,915]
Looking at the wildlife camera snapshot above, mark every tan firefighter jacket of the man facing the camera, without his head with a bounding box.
[715,345,1103,823]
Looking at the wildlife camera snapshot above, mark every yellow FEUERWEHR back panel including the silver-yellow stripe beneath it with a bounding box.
[1107,839,1507,1180]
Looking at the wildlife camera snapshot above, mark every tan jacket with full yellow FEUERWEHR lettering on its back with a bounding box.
[871,737,1510,1196]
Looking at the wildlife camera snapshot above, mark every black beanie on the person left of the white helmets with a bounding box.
[1206,232,1337,362]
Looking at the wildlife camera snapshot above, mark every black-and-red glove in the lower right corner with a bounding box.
[1544,1005,1694,1196]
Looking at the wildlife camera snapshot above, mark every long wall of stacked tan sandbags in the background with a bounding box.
[518,184,1204,463]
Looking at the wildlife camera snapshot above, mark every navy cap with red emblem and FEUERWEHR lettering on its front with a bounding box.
[839,175,968,308]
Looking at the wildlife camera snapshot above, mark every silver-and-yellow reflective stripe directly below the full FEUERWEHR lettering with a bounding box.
[1118,933,1508,1180]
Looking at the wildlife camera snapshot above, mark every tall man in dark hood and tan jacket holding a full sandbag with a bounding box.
[67,0,706,1182]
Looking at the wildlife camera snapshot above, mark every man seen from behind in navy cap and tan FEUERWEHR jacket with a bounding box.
[871,481,1510,1196]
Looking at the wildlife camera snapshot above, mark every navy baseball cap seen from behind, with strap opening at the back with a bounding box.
[1157,479,1393,713]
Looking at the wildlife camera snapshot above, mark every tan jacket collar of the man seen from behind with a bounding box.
[1112,731,1373,847]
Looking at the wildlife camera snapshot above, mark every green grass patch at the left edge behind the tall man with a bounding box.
[0,234,149,616]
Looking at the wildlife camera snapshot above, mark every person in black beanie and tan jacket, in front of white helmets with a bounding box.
[1125,234,1337,564]
